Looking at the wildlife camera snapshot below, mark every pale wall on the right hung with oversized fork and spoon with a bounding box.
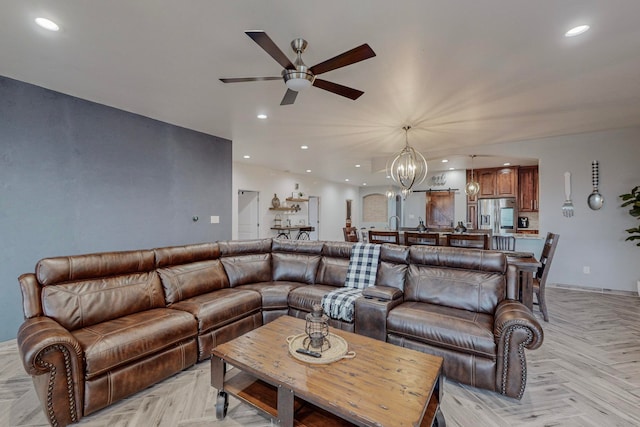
[476,127,640,292]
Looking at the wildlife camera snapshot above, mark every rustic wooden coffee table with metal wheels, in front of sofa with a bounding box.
[211,316,445,427]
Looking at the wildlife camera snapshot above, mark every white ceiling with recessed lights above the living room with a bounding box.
[0,0,640,185]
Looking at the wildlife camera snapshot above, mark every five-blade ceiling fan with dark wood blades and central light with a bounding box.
[220,31,376,105]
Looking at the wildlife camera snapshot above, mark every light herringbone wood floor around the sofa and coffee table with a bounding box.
[0,288,640,427]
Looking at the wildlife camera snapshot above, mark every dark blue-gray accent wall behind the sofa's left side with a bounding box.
[0,76,232,341]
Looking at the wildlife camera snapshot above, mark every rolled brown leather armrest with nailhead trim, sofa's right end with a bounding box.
[493,299,544,399]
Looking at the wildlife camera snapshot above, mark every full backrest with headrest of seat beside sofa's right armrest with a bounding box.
[404,246,507,314]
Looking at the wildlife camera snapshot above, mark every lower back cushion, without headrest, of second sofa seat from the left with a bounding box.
[158,260,229,305]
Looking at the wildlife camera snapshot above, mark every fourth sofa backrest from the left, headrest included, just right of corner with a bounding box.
[271,239,323,285]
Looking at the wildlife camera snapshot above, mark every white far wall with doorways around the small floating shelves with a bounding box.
[231,163,360,240]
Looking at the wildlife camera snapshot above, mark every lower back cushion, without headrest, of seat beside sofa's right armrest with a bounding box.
[404,264,506,314]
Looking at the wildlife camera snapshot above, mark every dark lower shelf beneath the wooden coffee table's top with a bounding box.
[216,369,445,427]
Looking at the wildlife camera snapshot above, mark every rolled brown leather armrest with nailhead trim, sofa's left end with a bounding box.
[17,316,84,426]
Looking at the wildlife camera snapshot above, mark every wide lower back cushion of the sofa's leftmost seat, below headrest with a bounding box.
[42,271,165,331]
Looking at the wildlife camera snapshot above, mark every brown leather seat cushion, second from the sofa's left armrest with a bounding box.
[171,288,262,335]
